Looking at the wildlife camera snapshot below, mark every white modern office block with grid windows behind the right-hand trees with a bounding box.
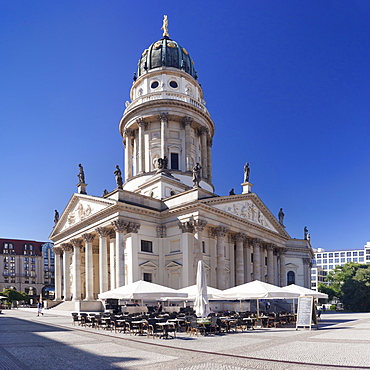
[311,242,370,290]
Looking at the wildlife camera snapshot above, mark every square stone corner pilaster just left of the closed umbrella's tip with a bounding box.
[179,221,195,287]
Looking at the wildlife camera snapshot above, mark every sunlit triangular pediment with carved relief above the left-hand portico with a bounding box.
[52,194,115,235]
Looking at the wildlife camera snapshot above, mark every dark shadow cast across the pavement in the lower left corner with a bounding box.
[0,315,144,370]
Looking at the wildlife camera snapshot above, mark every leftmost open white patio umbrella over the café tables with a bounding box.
[98,280,188,300]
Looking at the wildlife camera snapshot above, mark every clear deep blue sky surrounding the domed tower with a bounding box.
[0,0,370,250]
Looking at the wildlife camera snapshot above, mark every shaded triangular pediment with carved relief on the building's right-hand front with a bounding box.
[212,199,279,233]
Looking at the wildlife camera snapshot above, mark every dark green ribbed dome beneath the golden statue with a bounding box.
[138,36,198,79]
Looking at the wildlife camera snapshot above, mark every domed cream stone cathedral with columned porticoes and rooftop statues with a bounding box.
[50,17,313,309]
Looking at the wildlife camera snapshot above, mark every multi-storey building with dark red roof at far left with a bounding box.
[0,239,54,298]
